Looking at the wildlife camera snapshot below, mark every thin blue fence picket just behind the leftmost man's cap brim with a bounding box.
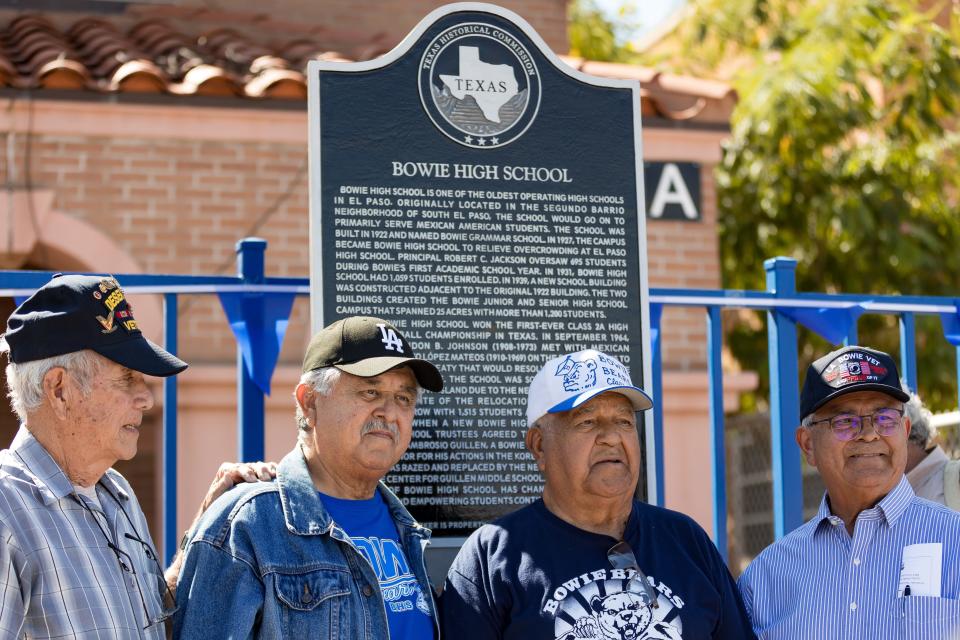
[163,293,178,567]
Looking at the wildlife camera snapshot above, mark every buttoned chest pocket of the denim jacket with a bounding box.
[274,569,351,640]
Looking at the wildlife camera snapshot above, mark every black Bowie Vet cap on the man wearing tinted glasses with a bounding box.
[800,346,910,420]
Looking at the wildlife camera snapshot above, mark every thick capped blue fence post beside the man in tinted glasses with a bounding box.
[763,257,803,539]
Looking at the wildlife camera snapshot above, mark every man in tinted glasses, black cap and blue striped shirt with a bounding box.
[740,346,960,640]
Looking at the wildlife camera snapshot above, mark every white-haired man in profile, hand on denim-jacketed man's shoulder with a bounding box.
[0,275,268,639]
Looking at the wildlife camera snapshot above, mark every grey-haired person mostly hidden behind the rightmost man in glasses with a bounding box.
[904,393,960,511]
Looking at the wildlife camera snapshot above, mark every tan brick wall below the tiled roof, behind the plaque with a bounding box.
[0,135,720,370]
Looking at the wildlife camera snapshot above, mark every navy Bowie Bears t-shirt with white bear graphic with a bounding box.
[440,500,754,640]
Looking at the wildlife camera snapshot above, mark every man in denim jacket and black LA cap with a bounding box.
[174,317,443,640]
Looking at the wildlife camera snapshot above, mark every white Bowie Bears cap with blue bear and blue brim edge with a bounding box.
[527,349,653,427]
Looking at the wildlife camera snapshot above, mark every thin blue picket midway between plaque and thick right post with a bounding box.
[707,307,728,560]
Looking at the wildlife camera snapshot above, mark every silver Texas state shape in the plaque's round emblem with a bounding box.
[440,47,518,124]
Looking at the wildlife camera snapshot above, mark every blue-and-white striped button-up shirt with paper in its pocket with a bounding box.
[739,478,960,640]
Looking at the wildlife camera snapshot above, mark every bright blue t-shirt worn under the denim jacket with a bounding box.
[318,491,433,640]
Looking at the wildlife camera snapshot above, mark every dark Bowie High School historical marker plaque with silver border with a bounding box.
[308,3,649,536]
